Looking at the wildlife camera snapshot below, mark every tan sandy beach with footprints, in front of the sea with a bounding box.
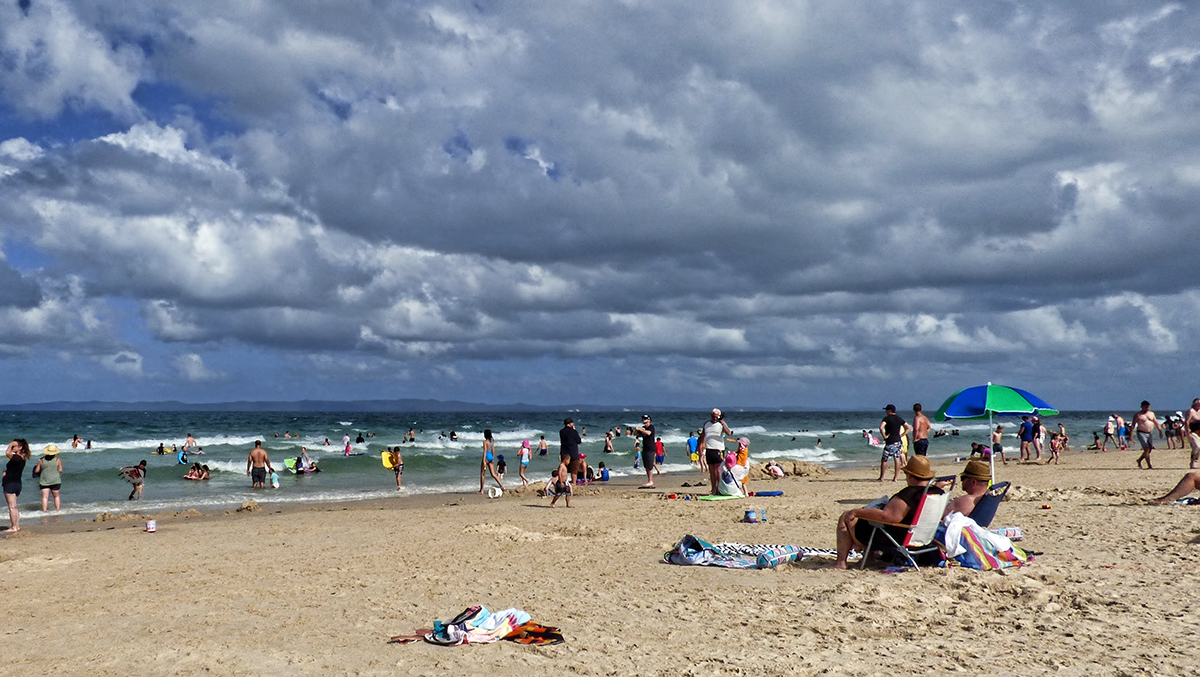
[0,450,1200,676]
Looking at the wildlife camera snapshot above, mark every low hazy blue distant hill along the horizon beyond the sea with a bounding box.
[0,400,692,413]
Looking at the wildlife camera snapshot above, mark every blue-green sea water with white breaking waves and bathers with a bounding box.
[0,411,1108,519]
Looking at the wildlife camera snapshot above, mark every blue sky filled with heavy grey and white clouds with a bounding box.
[0,0,1200,411]
